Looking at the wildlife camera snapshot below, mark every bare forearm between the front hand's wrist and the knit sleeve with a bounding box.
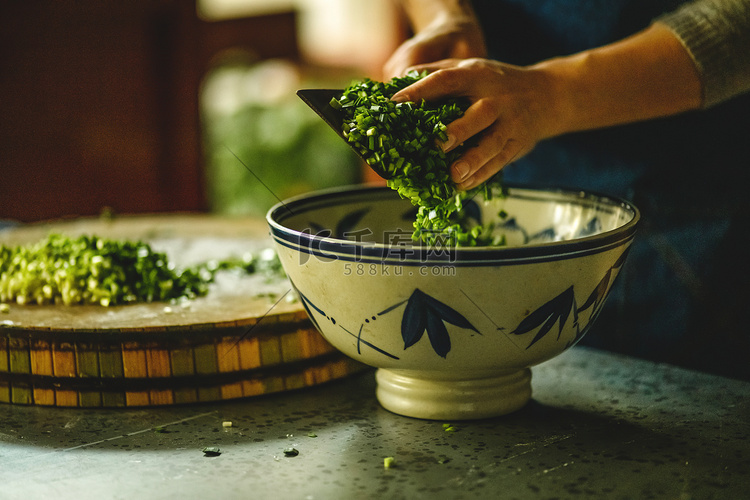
[530,24,702,137]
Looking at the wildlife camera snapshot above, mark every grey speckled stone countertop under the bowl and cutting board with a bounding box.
[0,347,750,500]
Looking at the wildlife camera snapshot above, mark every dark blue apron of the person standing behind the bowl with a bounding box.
[474,0,750,379]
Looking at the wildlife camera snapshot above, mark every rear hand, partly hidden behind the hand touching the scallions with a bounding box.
[383,18,487,80]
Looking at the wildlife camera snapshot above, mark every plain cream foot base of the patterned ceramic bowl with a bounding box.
[376,368,531,420]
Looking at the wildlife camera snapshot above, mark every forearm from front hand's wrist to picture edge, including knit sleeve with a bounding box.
[533,0,750,135]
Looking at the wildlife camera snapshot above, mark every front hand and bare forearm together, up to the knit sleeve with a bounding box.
[384,23,703,190]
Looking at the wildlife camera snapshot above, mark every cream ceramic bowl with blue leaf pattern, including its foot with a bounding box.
[267,186,640,419]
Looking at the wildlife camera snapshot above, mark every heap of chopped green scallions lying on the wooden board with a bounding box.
[0,234,283,306]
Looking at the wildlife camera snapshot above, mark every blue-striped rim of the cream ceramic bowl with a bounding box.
[266,183,641,266]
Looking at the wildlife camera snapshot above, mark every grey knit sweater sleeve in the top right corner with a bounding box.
[656,0,750,108]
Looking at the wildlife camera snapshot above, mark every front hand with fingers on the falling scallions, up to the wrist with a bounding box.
[393,59,556,190]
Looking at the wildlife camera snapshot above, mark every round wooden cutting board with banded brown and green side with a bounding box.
[0,214,365,407]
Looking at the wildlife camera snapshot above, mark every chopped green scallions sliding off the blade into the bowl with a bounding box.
[330,72,503,246]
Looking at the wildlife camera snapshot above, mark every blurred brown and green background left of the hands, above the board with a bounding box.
[0,0,406,222]
